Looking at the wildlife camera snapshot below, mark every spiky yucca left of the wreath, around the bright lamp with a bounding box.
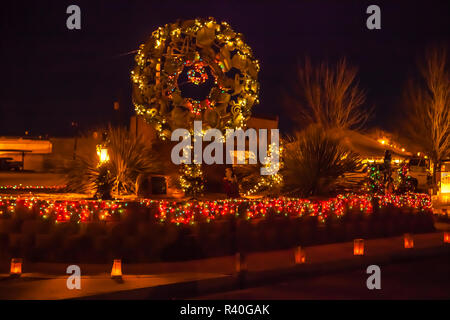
[67,126,162,196]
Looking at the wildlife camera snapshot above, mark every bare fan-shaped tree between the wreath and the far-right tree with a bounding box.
[287,58,371,129]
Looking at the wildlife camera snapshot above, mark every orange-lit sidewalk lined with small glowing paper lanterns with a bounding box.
[0,232,450,300]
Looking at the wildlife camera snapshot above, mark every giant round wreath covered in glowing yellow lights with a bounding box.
[131,18,259,139]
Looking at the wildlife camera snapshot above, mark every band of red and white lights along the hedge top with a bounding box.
[0,193,432,225]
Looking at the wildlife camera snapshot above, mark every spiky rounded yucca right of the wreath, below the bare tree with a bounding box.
[281,126,361,197]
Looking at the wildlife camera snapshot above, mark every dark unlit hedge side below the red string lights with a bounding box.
[0,207,434,263]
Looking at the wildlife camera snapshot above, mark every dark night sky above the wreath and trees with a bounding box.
[0,0,450,135]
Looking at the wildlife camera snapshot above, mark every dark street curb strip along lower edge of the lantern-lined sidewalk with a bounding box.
[77,245,450,300]
